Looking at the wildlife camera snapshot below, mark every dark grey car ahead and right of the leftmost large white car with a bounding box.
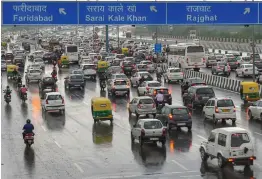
[64,74,85,90]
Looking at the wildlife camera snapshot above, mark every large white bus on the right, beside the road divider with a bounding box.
[168,43,206,71]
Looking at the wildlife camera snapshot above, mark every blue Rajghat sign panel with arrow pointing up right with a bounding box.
[167,2,259,25]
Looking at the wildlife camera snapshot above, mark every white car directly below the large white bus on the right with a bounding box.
[163,68,184,83]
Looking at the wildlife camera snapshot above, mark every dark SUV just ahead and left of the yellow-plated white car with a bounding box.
[183,86,215,109]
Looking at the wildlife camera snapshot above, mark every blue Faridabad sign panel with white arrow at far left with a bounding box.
[2,1,78,25]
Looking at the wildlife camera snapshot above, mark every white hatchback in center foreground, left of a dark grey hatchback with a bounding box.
[131,119,166,147]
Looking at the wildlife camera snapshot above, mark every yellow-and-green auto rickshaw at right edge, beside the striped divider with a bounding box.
[240,82,260,104]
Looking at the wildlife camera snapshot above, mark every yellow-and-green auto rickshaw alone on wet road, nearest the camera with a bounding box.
[91,97,113,123]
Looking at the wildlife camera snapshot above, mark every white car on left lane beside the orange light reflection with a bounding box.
[42,92,65,114]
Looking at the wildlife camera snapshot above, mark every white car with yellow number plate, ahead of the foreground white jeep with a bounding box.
[203,98,236,124]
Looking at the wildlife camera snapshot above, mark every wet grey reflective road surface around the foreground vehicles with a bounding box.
[1,62,262,179]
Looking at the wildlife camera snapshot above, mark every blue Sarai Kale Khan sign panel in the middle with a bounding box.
[79,2,166,25]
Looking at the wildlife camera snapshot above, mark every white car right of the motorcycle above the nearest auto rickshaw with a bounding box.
[107,79,130,96]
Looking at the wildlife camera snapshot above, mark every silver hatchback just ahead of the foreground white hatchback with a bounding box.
[128,96,157,118]
